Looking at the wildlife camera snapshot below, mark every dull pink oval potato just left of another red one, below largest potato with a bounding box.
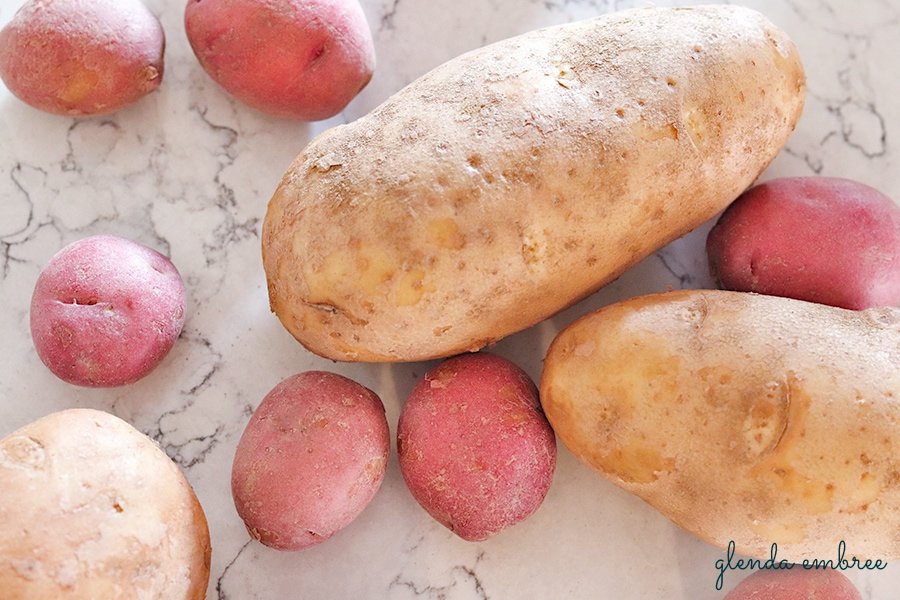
[231,371,390,550]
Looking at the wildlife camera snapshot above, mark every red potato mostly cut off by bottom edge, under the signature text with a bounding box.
[725,566,862,600]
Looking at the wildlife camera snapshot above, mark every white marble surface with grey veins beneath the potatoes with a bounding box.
[0,0,900,600]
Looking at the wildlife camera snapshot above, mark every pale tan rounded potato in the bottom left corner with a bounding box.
[0,409,210,600]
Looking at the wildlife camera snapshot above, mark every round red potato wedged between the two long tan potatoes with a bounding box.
[397,353,556,541]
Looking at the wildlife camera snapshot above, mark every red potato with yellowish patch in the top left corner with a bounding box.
[0,0,165,116]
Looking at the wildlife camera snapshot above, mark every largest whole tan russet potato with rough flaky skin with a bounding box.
[262,6,805,361]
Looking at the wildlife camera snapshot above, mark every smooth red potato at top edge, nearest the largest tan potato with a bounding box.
[184,0,375,121]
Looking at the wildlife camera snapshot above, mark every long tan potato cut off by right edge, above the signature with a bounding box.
[541,291,900,561]
